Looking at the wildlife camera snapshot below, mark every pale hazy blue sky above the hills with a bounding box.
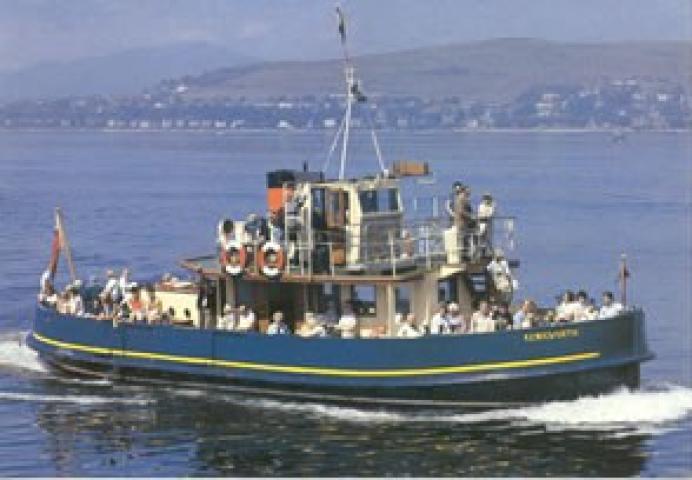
[0,0,692,70]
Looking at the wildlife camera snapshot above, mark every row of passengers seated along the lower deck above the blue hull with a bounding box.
[39,269,624,338]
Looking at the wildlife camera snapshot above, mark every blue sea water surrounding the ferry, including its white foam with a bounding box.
[0,128,692,476]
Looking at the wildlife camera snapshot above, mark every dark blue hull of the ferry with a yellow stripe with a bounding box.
[28,307,652,403]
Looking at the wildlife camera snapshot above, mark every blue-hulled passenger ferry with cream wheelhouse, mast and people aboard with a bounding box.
[27,11,652,406]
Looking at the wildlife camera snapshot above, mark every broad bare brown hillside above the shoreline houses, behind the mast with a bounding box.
[166,38,692,102]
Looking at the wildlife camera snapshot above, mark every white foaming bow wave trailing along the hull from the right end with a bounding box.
[228,385,692,435]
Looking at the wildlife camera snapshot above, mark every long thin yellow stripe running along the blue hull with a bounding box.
[32,332,601,377]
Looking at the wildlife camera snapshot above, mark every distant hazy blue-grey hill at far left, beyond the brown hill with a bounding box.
[0,42,256,101]
